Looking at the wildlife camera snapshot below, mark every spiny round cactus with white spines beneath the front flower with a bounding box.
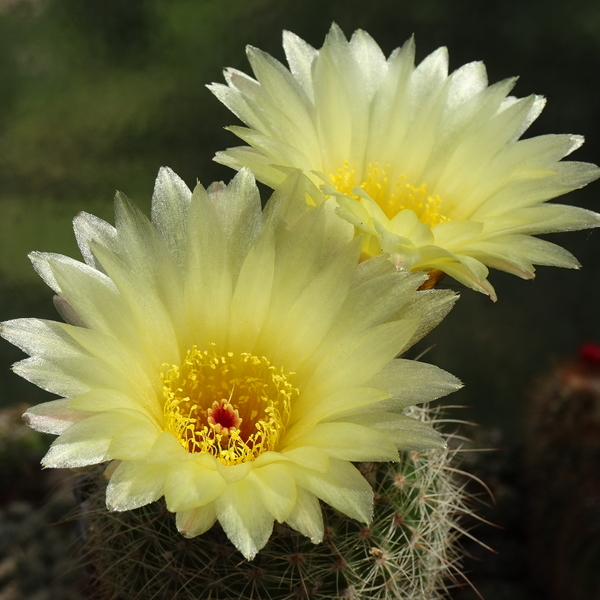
[71,407,469,600]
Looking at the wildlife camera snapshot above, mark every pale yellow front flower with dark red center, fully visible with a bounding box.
[1,169,459,559]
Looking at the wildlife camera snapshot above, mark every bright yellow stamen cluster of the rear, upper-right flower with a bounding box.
[329,161,450,227]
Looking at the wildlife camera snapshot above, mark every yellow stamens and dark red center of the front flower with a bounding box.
[161,344,299,465]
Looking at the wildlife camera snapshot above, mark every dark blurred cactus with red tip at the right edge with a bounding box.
[525,344,600,600]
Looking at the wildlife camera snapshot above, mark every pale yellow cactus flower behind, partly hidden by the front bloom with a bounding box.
[209,25,600,299]
